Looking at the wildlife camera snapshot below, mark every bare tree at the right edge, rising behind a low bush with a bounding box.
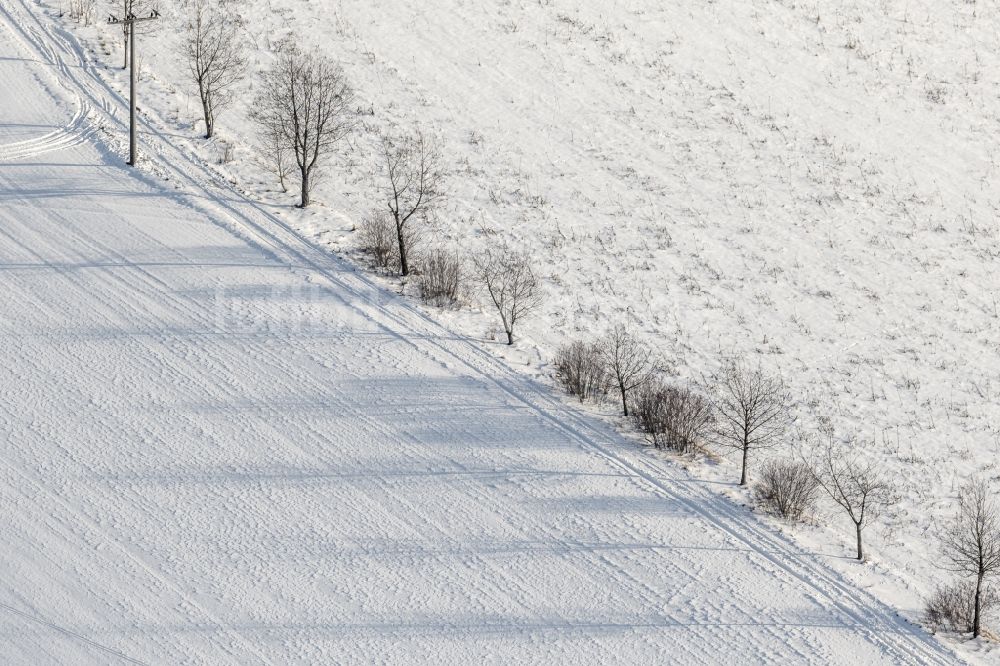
[942,479,1000,637]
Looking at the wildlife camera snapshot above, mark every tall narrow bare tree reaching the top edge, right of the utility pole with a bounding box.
[183,0,247,139]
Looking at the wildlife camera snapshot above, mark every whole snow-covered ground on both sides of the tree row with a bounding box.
[0,0,1000,664]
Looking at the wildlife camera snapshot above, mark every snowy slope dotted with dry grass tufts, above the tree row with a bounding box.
[54,0,1000,659]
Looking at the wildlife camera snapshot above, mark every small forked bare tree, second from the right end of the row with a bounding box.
[815,441,896,561]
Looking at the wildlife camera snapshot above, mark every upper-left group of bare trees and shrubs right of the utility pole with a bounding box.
[178,0,540,344]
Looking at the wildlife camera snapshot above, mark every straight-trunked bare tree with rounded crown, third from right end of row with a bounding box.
[713,360,792,486]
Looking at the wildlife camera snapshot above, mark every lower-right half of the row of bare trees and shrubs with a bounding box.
[555,334,1000,637]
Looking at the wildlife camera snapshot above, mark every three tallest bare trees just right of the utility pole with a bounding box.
[183,0,445,236]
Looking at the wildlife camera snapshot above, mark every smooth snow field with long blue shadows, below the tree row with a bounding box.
[0,0,955,664]
